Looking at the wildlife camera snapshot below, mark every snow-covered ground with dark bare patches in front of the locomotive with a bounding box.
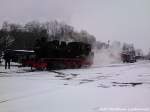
[0,61,150,112]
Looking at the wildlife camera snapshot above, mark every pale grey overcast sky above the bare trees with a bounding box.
[0,0,150,51]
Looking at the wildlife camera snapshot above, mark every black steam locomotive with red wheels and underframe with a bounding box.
[22,40,94,69]
